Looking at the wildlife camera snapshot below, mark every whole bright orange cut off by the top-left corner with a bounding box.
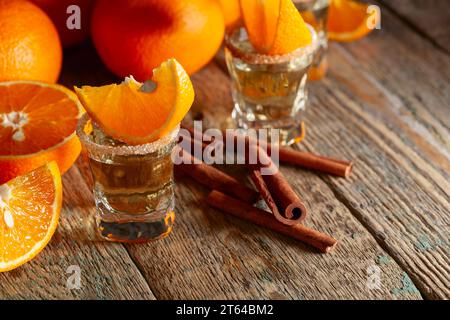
[0,0,62,82]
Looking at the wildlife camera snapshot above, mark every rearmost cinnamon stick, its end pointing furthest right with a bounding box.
[183,126,353,178]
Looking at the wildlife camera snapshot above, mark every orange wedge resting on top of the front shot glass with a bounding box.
[75,59,194,145]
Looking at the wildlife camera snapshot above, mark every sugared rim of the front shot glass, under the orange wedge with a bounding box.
[77,113,180,156]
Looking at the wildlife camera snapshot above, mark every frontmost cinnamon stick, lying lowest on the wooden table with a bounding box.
[207,190,337,253]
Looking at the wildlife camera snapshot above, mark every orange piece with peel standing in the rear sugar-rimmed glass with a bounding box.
[241,0,312,55]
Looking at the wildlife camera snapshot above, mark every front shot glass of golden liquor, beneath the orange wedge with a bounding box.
[77,114,179,242]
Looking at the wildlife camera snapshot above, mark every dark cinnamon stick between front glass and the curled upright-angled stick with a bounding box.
[175,146,259,203]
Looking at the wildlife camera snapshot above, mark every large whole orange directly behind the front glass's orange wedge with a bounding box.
[91,0,225,81]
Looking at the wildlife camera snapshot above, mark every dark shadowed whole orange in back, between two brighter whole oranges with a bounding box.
[31,0,94,47]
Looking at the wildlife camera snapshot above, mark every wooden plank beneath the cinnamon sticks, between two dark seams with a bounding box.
[123,64,421,299]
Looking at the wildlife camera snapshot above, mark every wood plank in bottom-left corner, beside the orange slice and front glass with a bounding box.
[0,160,155,300]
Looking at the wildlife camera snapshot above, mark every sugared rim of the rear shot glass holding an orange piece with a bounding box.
[225,24,319,64]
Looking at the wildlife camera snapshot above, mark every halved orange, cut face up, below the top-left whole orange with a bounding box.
[0,81,83,183]
